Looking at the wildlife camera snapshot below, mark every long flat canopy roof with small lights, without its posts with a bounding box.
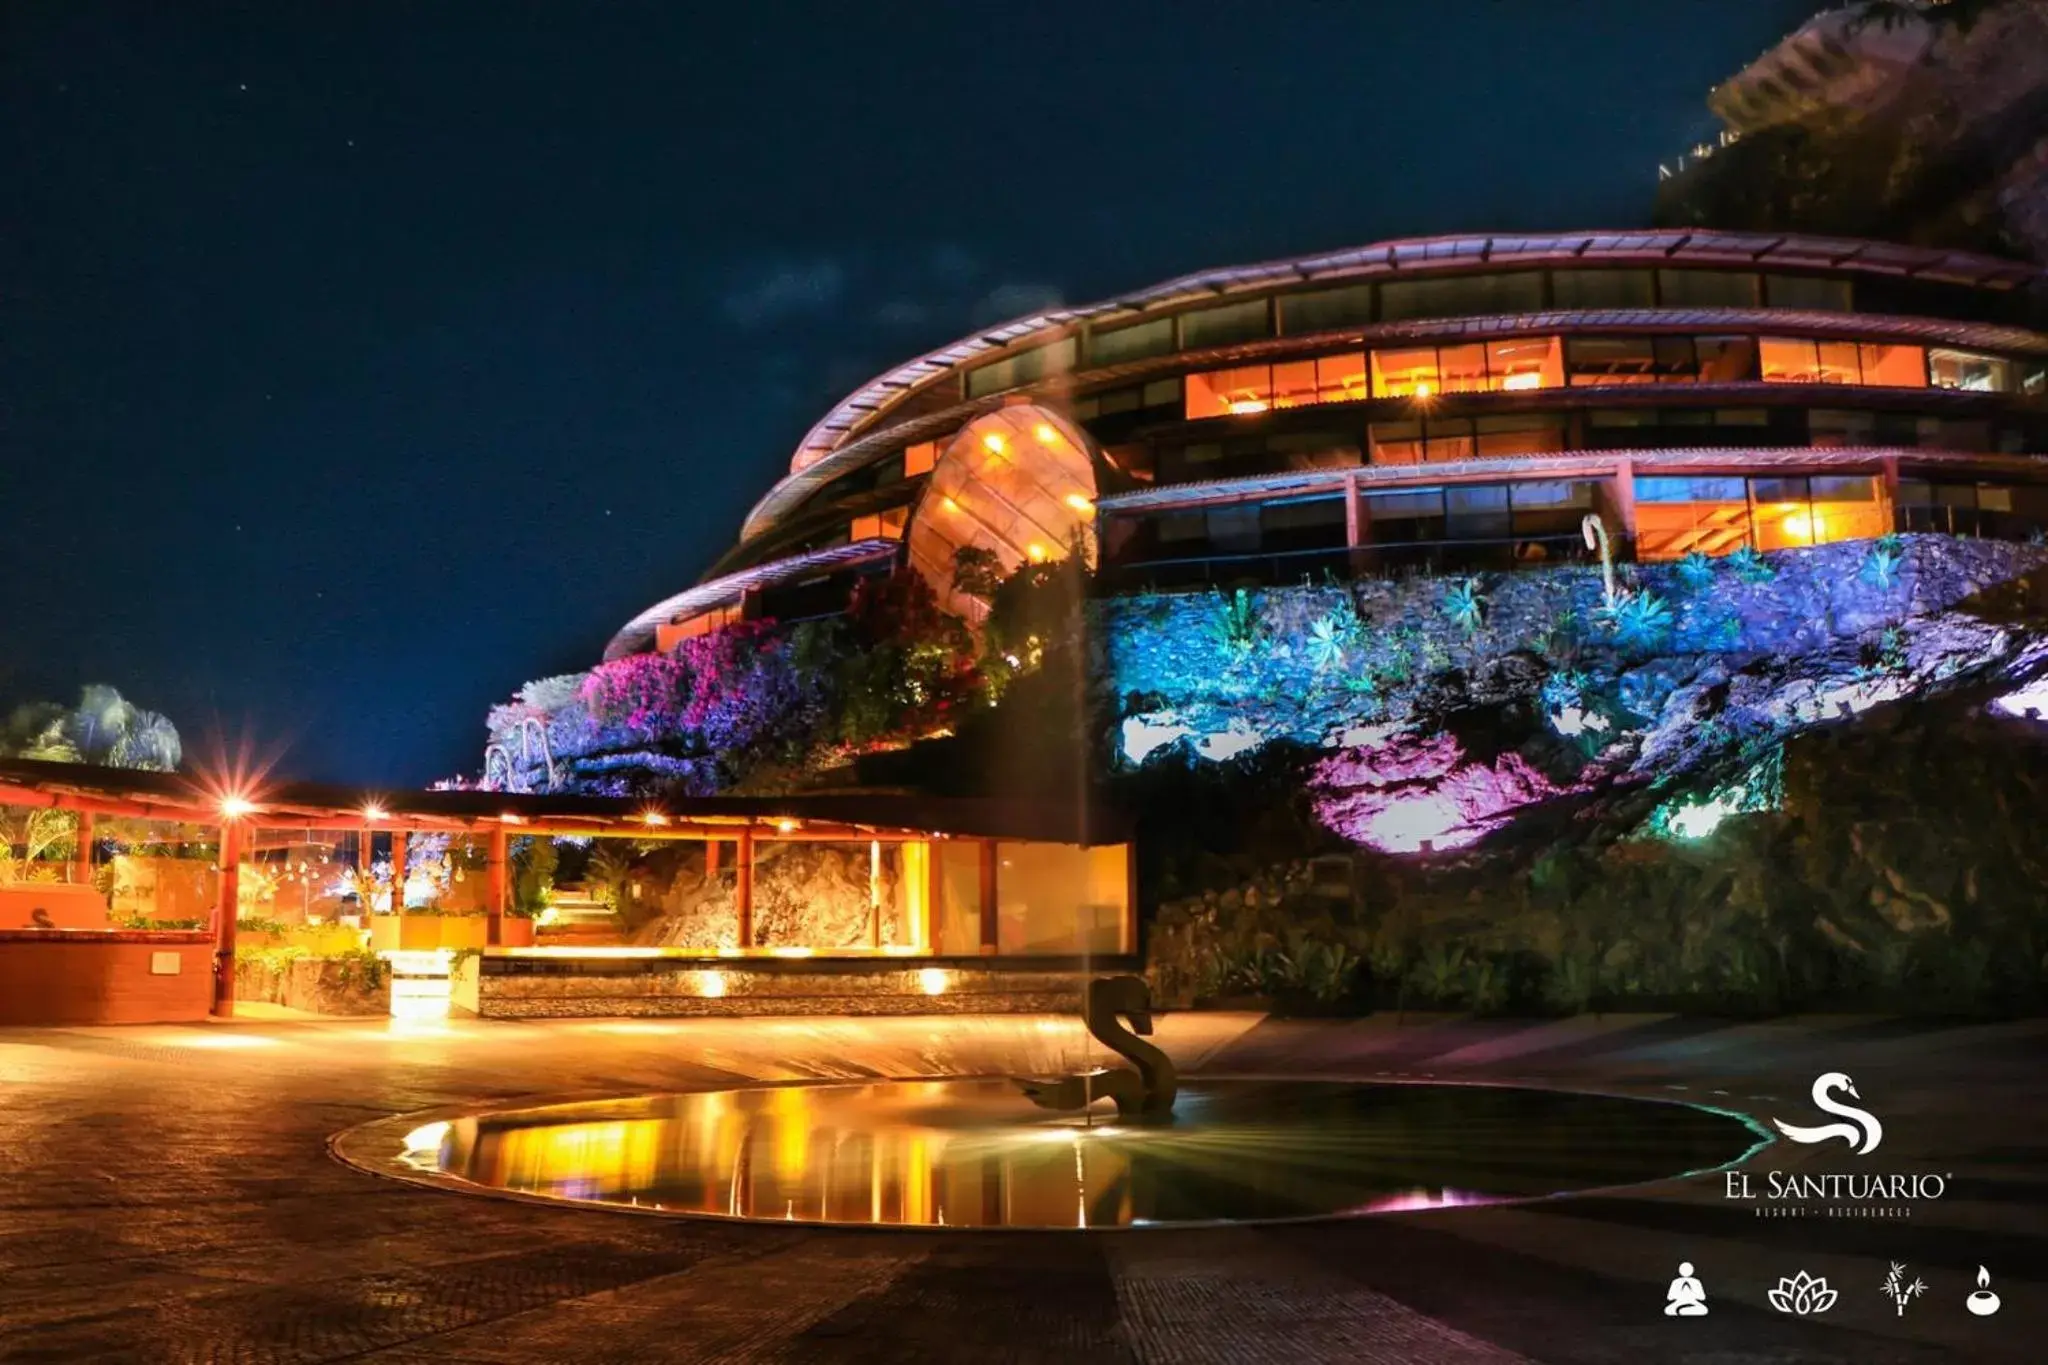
[0,759,1130,843]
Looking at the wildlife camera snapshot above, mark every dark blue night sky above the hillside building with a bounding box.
[0,0,1819,786]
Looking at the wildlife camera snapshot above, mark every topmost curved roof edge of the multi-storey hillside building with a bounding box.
[770,229,2040,489]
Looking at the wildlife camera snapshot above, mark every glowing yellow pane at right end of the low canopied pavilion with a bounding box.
[995,843,1133,954]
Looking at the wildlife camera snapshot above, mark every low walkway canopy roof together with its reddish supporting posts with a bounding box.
[0,759,1130,1015]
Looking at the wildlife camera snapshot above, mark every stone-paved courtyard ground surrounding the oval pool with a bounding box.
[0,1015,2048,1365]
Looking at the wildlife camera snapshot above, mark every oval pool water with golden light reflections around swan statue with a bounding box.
[406,1081,1757,1228]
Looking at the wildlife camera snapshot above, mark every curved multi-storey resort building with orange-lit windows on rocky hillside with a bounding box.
[606,229,2048,659]
